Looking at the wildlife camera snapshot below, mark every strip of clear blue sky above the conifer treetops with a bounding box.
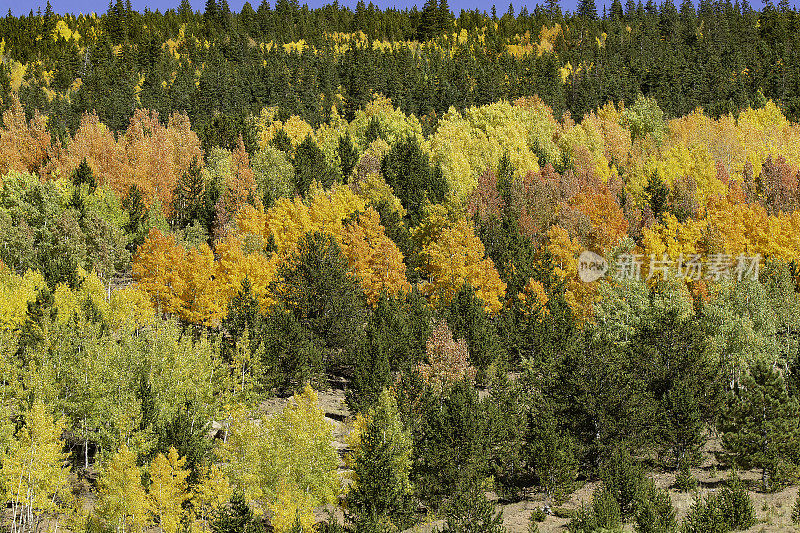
[0,0,777,16]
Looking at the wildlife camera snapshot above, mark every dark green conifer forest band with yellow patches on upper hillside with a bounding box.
[0,0,800,151]
